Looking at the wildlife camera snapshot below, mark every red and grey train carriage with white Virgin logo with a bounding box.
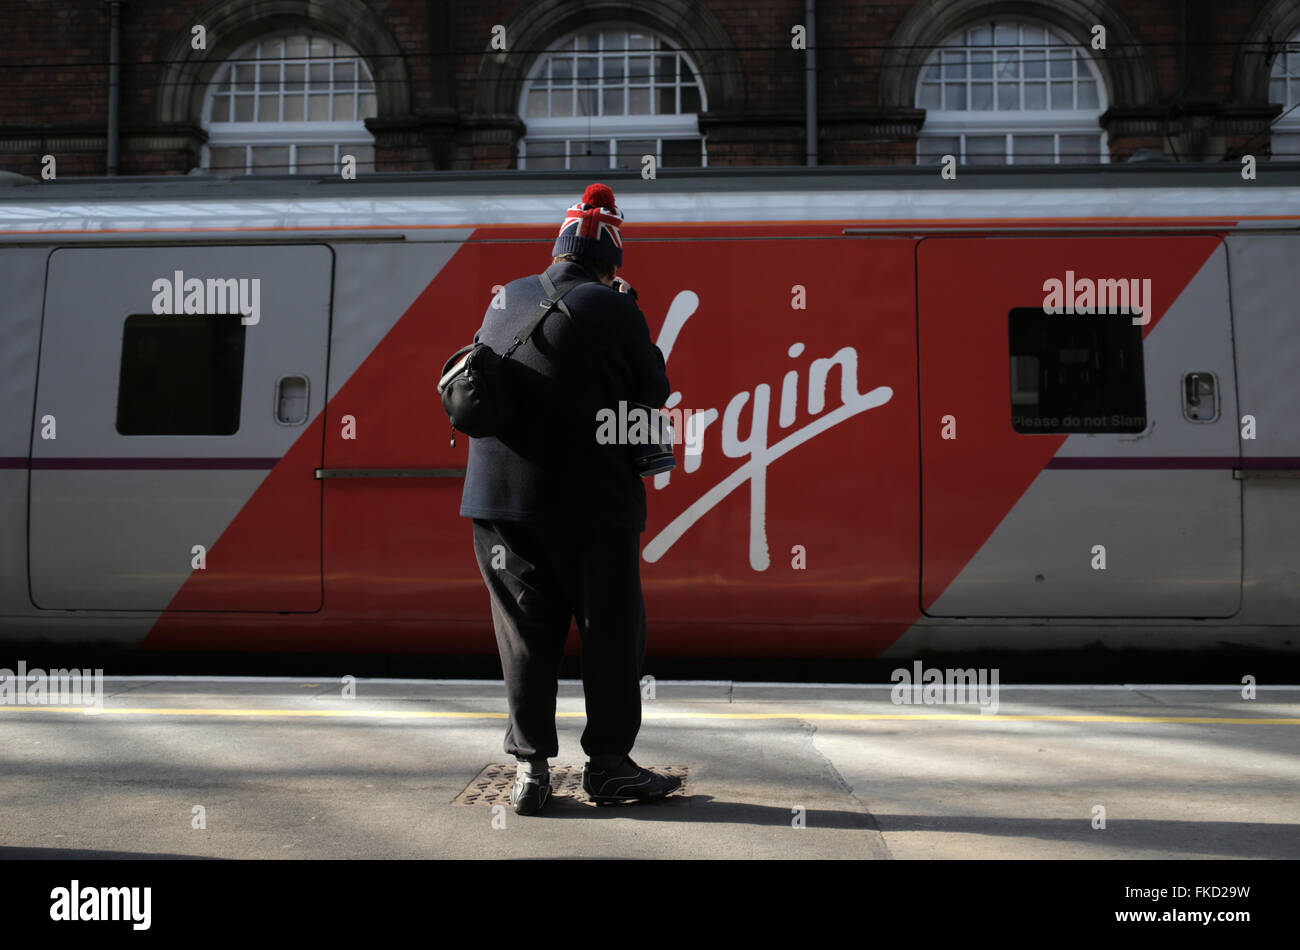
[0,165,1300,658]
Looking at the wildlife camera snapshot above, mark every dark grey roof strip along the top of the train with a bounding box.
[0,161,1300,203]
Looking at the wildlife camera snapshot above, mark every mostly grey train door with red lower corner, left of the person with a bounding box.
[29,244,333,611]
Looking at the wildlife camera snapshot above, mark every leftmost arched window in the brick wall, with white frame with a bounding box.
[203,34,376,175]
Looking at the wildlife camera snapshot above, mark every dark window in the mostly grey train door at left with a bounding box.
[117,313,244,435]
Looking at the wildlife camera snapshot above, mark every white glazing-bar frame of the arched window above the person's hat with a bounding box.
[517,22,709,169]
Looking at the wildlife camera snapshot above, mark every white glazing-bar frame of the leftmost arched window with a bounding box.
[200,30,378,174]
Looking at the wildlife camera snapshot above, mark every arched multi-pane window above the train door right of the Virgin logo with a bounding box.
[917,19,1109,165]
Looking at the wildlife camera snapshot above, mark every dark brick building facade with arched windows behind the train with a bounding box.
[0,0,1300,177]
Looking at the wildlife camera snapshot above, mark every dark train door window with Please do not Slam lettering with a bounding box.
[1008,307,1147,434]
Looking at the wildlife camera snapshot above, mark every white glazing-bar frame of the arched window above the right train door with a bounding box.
[913,17,1110,165]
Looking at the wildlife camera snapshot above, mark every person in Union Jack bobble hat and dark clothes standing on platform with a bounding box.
[460,185,681,815]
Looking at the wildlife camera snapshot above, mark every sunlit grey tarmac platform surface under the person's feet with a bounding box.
[0,677,1300,859]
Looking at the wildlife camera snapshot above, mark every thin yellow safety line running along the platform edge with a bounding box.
[0,704,1300,725]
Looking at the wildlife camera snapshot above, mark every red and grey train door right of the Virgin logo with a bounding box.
[918,237,1242,617]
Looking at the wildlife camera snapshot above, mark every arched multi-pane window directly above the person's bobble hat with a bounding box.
[519,26,707,170]
